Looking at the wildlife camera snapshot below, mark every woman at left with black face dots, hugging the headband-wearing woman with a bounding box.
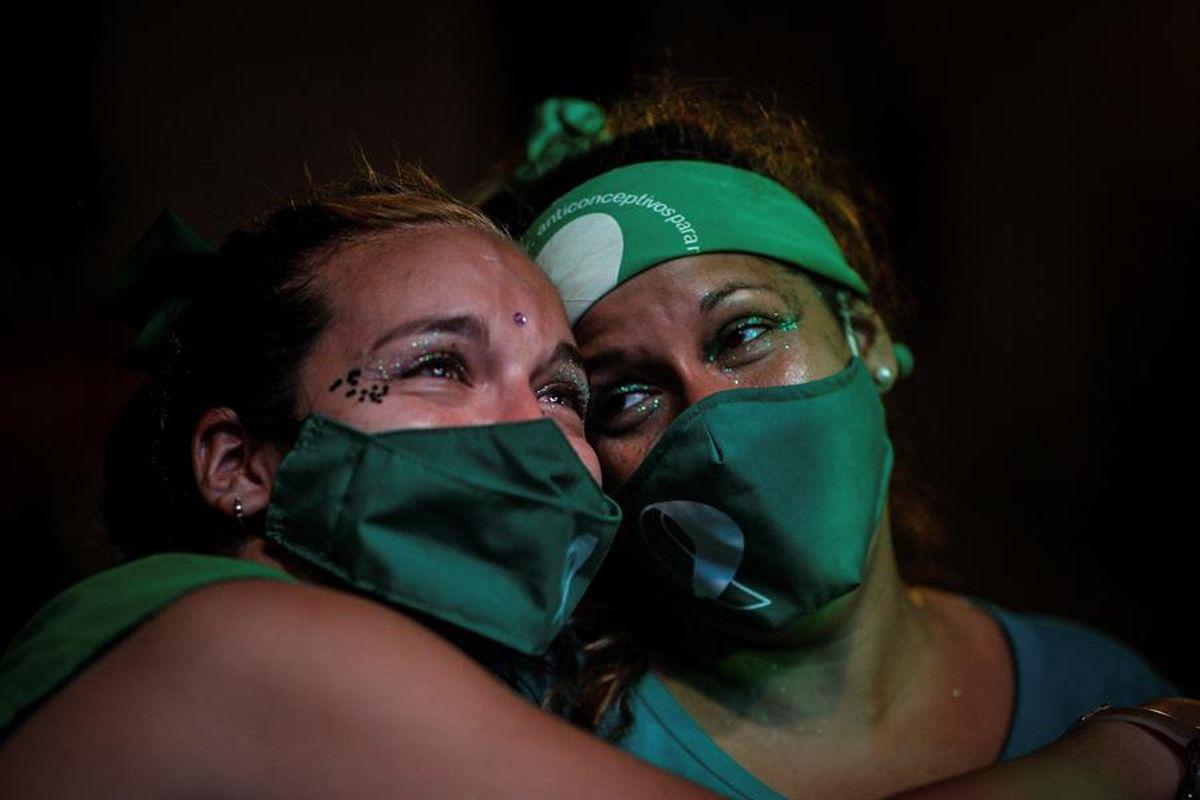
[0,173,729,798]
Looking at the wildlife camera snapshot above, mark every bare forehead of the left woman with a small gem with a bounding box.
[318,227,565,338]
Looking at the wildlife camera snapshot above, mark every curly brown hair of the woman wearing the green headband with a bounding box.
[484,74,941,738]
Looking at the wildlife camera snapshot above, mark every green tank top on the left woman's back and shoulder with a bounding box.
[0,553,295,739]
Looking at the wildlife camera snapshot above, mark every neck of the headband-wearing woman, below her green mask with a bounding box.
[662,515,931,730]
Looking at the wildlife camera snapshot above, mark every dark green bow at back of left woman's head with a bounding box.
[104,210,217,368]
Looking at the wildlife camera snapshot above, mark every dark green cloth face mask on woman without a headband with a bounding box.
[266,416,620,654]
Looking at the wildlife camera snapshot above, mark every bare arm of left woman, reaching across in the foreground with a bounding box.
[0,582,712,799]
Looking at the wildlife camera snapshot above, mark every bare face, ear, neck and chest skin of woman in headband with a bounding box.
[576,254,1013,798]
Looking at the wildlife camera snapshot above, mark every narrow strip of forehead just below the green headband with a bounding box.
[575,253,811,344]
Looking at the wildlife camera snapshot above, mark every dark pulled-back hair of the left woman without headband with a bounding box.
[104,166,503,558]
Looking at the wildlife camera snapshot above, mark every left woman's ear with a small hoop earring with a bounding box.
[192,408,282,517]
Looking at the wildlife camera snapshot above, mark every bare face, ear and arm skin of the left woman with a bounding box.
[0,228,712,799]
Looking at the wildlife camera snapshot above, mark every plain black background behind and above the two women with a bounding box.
[0,1,1200,694]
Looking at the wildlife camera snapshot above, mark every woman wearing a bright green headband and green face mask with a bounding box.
[485,84,1196,798]
